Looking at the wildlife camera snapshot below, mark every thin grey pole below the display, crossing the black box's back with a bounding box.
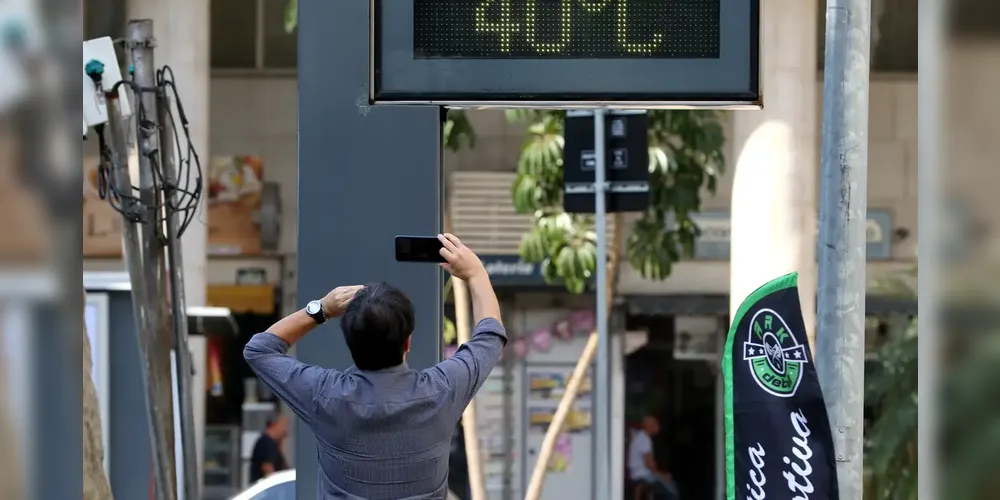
[591,109,612,499]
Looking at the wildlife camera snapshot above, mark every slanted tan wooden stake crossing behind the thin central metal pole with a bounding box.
[524,214,622,500]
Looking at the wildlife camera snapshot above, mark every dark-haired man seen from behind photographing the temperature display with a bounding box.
[243,234,507,500]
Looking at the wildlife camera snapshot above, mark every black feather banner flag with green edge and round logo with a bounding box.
[722,273,839,500]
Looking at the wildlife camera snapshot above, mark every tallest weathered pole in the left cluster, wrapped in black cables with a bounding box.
[126,19,177,500]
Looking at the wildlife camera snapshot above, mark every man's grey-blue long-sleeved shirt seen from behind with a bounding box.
[243,318,507,500]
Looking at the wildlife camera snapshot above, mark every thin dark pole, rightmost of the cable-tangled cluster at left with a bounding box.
[156,88,201,500]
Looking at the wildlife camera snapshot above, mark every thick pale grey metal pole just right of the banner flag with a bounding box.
[816,0,871,500]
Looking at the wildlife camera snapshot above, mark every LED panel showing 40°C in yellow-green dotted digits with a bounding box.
[413,0,720,59]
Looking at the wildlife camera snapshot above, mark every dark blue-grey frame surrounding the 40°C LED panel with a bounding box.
[372,0,763,109]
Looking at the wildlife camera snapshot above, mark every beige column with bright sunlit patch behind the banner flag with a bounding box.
[730,0,819,344]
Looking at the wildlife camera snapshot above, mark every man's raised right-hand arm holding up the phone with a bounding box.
[432,234,507,418]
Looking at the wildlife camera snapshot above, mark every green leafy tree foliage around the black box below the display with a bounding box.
[508,110,725,293]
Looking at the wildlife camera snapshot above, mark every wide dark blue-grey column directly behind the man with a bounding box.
[295,0,443,500]
